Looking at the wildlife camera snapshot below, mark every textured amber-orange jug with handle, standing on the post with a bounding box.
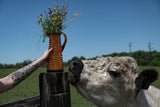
[47,33,67,72]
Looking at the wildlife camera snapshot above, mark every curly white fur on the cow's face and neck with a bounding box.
[76,57,160,107]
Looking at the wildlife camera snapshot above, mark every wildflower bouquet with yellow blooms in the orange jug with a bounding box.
[38,0,81,41]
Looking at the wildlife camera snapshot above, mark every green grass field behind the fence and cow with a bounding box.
[0,67,160,107]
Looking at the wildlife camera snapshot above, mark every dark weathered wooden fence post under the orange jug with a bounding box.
[39,72,71,107]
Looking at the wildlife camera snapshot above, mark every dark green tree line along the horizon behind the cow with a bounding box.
[0,50,160,68]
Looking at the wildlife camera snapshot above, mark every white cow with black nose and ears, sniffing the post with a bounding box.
[68,56,160,107]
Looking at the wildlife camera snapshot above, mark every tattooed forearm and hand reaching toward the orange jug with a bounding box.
[0,48,52,93]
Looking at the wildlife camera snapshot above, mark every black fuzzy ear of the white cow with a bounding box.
[135,69,158,94]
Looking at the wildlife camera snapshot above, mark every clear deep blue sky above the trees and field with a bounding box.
[0,0,160,64]
